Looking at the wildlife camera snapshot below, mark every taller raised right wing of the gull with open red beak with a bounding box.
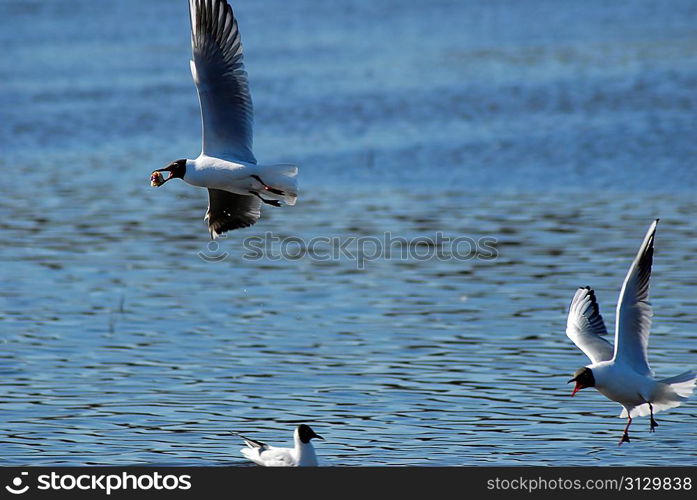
[615,219,658,375]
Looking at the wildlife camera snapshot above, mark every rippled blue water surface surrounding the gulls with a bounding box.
[0,0,697,465]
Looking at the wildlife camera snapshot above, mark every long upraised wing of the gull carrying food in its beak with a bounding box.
[189,0,256,163]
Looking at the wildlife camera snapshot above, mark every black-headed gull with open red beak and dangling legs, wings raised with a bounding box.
[566,219,697,444]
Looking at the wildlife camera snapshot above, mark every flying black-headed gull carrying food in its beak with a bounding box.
[150,0,298,238]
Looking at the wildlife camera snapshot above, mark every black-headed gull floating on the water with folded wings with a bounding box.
[238,424,324,467]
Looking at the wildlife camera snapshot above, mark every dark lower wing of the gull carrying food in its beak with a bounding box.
[204,189,261,238]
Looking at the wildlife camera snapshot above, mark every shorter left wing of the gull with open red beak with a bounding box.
[566,286,614,363]
